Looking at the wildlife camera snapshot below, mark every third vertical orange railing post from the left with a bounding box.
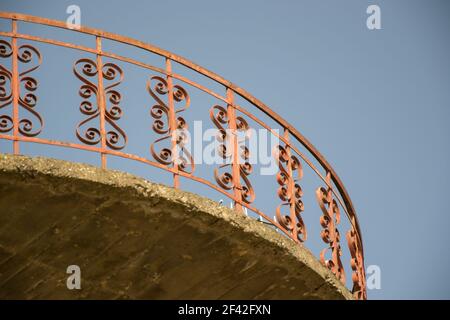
[166,58,180,189]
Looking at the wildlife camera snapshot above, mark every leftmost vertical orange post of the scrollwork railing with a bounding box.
[11,19,20,154]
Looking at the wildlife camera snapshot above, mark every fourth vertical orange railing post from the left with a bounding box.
[227,88,242,212]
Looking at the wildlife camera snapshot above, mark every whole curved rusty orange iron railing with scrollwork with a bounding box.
[0,12,366,299]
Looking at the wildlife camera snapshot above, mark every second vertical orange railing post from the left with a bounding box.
[96,36,106,169]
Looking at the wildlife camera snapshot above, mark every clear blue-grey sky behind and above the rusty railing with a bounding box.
[0,0,450,299]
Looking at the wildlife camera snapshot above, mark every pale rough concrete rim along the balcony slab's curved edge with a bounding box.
[0,154,353,300]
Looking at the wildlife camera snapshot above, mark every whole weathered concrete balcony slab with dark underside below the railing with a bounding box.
[0,155,351,299]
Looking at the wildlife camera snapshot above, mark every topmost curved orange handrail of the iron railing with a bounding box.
[0,12,363,252]
